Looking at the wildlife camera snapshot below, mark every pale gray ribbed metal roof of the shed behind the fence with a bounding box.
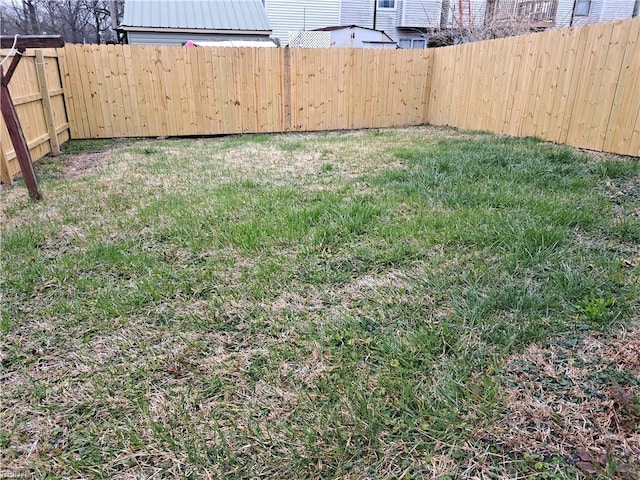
[121,0,271,31]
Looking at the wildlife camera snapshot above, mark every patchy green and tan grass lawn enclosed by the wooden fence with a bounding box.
[0,128,640,479]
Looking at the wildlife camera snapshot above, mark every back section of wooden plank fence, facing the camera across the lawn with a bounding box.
[62,45,430,138]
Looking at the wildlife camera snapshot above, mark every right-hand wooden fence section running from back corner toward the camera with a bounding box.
[426,18,640,156]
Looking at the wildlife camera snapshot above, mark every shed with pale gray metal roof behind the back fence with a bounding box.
[116,0,271,45]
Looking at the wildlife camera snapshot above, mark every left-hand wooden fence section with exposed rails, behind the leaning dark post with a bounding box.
[0,50,69,183]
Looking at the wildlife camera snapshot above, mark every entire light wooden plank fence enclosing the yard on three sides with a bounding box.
[0,18,640,182]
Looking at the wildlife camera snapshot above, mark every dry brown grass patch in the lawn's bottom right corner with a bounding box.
[480,327,640,473]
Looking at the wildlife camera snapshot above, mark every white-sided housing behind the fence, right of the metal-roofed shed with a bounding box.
[264,0,639,48]
